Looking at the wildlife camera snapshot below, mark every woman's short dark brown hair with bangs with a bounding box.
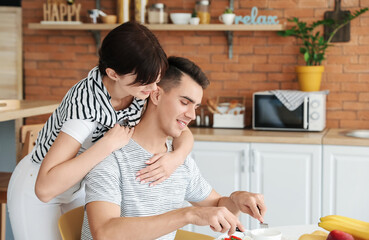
[99,22,168,85]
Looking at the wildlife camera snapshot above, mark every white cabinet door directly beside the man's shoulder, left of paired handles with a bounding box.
[187,141,249,237]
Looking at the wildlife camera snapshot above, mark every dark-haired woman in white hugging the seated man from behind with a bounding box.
[8,22,193,240]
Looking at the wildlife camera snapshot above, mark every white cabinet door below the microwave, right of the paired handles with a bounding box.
[250,143,321,228]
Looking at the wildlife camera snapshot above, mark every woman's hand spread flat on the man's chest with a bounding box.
[136,152,183,187]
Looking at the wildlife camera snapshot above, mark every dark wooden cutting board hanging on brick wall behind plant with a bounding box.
[324,0,350,42]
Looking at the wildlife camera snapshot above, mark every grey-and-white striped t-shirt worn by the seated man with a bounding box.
[81,139,212,240]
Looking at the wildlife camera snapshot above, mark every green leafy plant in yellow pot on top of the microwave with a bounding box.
[278,8,368,91]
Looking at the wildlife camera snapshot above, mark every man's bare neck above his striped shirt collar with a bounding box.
[132,112,168,154]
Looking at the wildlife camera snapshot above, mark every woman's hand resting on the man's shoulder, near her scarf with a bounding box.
[101,124,134,152]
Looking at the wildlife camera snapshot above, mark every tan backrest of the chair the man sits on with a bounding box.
[58,206,84,240]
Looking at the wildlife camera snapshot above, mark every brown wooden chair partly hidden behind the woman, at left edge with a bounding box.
[0,123,43,240]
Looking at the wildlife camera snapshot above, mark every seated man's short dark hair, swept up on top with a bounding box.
[158,56,209,92]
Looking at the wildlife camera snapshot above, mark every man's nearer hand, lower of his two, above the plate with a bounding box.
[191,207,246,235]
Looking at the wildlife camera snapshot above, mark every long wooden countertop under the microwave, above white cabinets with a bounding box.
[190,127,369,146]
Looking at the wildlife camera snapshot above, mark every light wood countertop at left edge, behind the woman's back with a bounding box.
[0,100,59,122]
